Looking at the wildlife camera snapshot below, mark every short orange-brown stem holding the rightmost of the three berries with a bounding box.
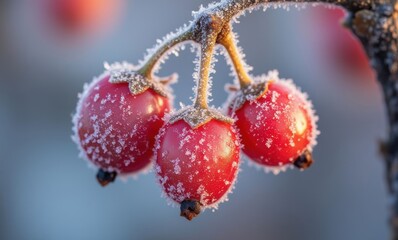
[217,24,252,88]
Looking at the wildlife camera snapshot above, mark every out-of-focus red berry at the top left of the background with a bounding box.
[44,0,121,32]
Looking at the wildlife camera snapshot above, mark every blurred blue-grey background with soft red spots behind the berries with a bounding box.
[0,0,389,240]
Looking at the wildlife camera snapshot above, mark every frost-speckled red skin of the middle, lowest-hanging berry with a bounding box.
[155,120,239,206]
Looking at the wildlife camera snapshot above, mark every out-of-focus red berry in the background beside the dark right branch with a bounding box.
[313,7,373,79]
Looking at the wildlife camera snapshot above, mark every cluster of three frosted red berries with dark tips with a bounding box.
[73,62,318,220]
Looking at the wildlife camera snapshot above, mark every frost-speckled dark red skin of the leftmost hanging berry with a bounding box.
[77,76,170,174]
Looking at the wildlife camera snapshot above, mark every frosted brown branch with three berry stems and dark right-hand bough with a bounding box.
[135,0,398,236]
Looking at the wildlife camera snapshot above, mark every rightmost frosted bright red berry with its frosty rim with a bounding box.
[228,71,319,170]
